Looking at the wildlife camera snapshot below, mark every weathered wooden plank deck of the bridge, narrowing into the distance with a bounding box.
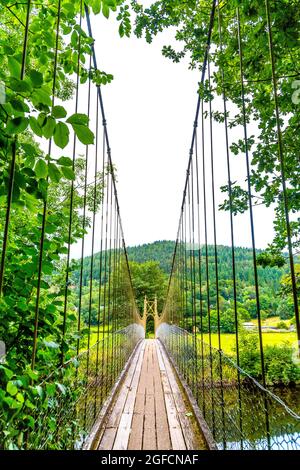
[98,340,205,450]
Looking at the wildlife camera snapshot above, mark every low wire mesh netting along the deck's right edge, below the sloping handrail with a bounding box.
[157,323,300,450]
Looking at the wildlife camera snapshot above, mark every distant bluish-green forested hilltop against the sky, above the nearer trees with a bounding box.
[75,240,286,291]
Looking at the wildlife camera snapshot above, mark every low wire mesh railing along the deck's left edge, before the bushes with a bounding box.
[15,324,141,450]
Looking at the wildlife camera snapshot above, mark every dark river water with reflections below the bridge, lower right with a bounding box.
[205,386,300,450]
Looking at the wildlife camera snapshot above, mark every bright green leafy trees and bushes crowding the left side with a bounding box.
[0,0,131,449]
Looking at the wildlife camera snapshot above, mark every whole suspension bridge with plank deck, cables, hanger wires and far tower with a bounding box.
[0,1,300,450]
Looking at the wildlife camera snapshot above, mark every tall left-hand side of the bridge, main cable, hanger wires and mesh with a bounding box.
[0,0,144,449]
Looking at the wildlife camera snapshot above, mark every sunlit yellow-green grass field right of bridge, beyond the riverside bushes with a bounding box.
[199,332,297,354]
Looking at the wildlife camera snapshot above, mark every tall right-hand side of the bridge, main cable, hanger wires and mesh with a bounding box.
[157,0,300,449]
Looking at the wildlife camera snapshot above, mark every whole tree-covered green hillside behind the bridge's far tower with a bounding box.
[74,241,292,326]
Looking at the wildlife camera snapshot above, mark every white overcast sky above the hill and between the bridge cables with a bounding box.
[72,2,273,257]
